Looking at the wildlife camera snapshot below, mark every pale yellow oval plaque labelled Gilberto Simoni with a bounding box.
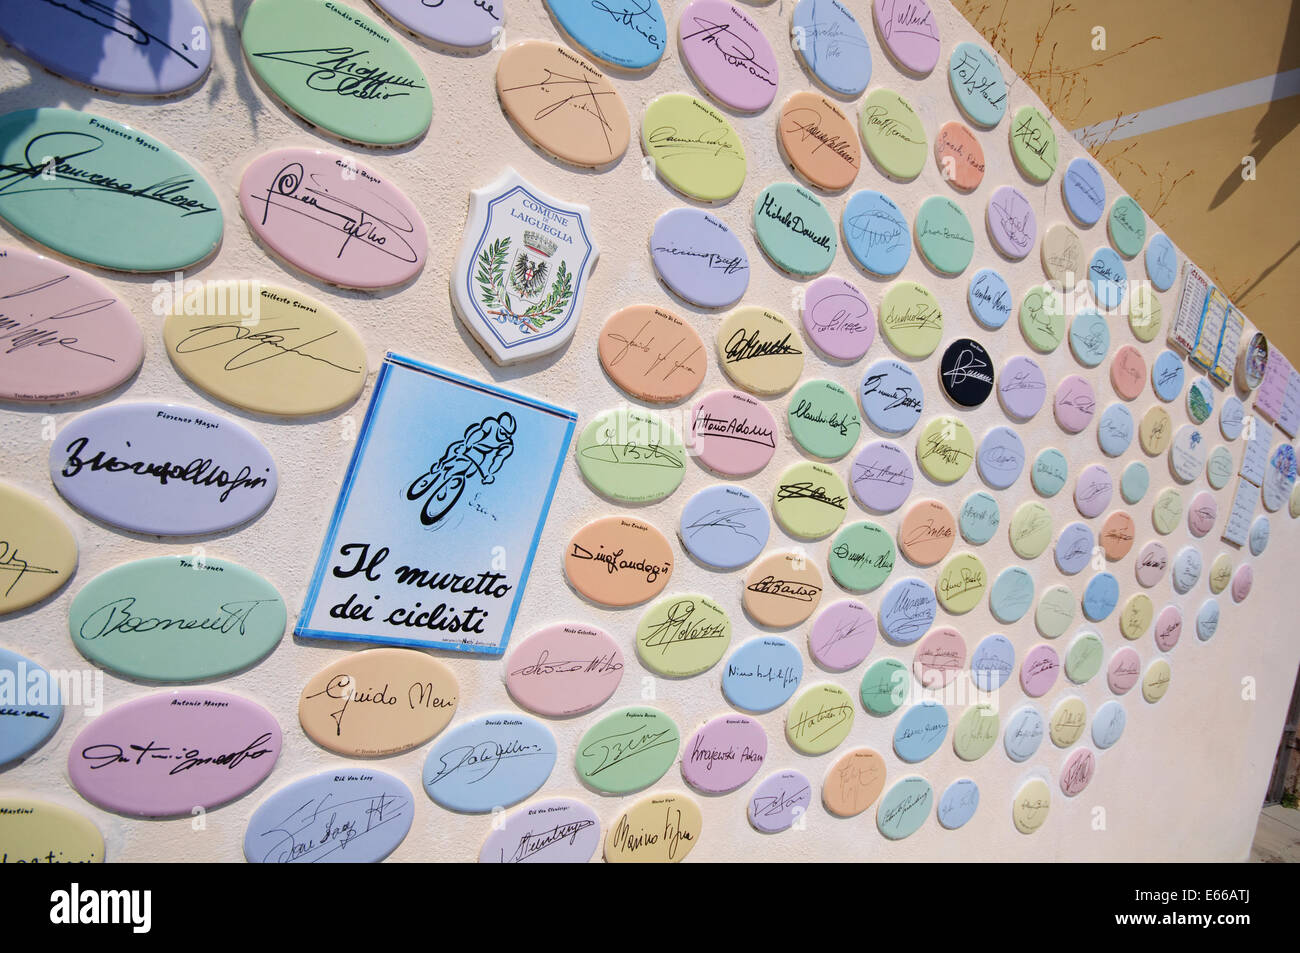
[163,282,367,416]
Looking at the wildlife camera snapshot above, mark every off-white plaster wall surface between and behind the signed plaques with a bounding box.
[0,0,1300,861]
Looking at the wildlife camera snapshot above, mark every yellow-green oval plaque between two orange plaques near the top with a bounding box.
[641,92,749,202]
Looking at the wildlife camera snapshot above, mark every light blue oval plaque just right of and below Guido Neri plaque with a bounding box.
[424,712,555,814]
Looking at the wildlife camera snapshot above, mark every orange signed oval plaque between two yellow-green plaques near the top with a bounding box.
[776,90,862,192]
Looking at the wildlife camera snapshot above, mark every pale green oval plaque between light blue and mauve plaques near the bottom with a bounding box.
[575,706,681,794]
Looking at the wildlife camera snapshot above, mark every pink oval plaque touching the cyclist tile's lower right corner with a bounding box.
[506,623,623,716]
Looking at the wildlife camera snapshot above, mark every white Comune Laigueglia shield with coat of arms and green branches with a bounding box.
[451,169,601,364]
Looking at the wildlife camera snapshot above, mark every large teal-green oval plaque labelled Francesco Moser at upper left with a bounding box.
[0,108,220,272]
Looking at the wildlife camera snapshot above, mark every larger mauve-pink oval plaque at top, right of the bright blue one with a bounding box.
[677,0,777,113]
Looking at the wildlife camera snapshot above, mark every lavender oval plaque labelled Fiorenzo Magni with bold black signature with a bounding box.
[49,403,277,536]
